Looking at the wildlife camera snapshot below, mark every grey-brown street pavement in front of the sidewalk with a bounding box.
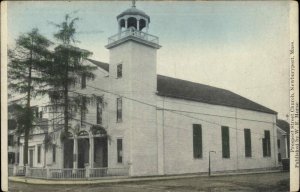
[9,172,289,192]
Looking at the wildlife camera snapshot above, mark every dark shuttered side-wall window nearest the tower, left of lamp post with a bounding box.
[193,124,202,159]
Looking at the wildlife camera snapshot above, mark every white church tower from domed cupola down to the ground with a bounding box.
[106,1,161,176]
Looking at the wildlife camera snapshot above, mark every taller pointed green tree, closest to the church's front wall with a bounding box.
[48,15,96,138]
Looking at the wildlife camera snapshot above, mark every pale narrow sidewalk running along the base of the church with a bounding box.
[8,170,282,185]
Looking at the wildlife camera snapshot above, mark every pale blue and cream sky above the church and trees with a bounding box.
[8,1,289,119]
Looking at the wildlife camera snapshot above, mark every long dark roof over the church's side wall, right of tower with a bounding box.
[157,75,277,114]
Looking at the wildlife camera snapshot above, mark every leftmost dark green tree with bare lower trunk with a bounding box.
[8,29,52,165]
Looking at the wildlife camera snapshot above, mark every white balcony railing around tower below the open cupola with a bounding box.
[108,28,159,44]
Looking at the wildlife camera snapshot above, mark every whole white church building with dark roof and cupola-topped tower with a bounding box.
[14,5,286,176]
